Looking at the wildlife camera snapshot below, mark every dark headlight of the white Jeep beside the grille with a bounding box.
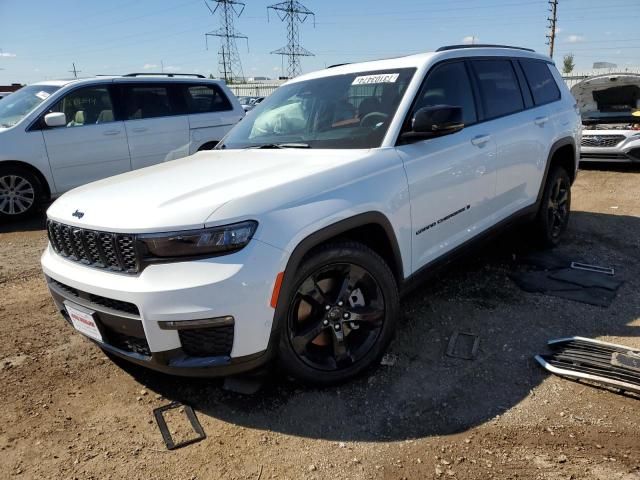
[138,220,258,258]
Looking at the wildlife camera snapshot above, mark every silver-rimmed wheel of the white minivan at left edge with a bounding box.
[0,166,43,221]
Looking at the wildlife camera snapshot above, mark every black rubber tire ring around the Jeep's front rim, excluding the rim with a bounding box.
[278,243,399,385]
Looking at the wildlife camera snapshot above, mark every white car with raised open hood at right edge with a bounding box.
[571,73,640,163]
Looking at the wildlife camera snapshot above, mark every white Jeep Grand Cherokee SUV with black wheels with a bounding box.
[42,45,580,384]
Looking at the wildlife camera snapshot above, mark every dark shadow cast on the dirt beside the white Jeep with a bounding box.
[114,212,640,441]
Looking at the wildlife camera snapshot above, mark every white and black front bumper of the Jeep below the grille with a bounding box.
[42,239,284,376]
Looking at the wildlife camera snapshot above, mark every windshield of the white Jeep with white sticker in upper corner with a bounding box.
[217,68,415,149]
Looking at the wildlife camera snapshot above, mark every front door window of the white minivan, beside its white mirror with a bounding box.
[51,87,114,127]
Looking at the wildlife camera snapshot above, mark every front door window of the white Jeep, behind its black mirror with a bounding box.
[415,62,477,125]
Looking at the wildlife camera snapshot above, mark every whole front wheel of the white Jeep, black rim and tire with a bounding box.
[279,242,400,385]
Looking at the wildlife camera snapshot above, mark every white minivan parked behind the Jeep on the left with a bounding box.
[0,74,244,221]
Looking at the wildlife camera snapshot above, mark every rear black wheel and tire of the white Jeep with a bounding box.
[534,165,571,247]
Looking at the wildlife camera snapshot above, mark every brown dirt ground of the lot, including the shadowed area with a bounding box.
[0,166,640,480]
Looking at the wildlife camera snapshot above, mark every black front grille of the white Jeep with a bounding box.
[47,220,140,273]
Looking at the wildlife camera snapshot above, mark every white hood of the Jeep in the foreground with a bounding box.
[47,149,369,233]
